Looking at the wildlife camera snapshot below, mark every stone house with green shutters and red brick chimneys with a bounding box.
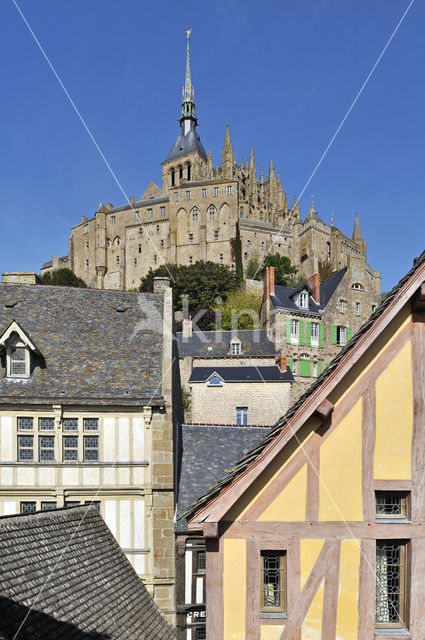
[261,258,380,399]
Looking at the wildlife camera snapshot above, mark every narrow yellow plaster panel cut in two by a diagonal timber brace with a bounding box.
[300,540,324,640]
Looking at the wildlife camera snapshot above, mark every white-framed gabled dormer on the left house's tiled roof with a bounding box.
[0,321,38,379]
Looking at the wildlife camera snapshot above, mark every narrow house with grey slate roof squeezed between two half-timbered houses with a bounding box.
[174,424,270,640]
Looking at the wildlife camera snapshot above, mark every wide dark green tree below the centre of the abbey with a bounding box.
[139,261,239,316]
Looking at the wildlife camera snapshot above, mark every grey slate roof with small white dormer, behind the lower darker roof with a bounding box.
[177,329,276,359]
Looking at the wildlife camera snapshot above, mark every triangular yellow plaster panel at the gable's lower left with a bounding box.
[258,465,307,522]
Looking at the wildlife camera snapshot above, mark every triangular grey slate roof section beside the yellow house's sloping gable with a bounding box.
[175,425,270,531]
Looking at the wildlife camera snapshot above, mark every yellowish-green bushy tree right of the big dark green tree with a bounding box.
[216,289,263,331]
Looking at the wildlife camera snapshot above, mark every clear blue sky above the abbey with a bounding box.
[0,0,425,289]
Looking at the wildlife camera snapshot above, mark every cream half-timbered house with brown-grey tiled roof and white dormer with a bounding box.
[0,276,181,619]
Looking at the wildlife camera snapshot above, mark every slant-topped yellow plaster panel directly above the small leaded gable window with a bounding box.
[374,341,413,480]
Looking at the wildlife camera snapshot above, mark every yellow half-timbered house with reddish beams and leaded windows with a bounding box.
[184,252,425,640]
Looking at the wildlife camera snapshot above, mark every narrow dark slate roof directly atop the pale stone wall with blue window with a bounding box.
[189,364,294,383]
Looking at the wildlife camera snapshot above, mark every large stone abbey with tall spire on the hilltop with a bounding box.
[41,32,380,296]
